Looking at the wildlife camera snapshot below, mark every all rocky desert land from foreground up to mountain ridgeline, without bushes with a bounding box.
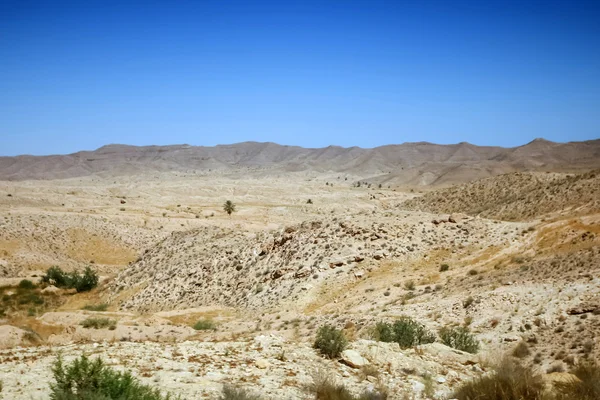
[0,140,600,399]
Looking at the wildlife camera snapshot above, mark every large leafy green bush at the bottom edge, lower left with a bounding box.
[50,355,171,400]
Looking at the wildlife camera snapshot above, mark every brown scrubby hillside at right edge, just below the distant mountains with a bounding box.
[402,170,600,221]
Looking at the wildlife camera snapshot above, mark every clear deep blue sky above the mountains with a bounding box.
[0,0,600,155]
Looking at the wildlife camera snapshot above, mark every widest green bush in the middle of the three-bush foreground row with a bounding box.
[375,317,435,349]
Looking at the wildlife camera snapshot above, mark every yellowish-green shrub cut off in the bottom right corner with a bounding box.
[555,362,600,400]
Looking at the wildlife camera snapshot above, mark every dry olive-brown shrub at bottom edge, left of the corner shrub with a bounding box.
[451,358,546,400]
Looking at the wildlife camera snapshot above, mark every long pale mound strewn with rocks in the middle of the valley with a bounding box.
[112,213,520,311]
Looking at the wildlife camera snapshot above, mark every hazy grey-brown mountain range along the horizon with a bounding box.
[0,139,600,186]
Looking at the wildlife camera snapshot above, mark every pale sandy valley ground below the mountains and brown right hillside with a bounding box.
[0,173,600,399]
